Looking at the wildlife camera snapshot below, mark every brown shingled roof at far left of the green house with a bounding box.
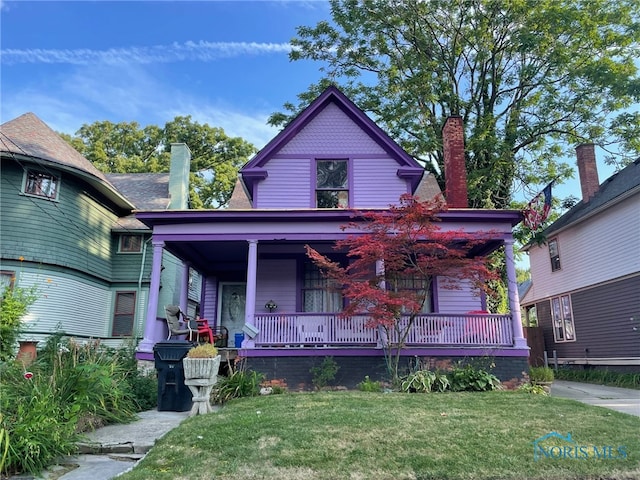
[0,112,133,210]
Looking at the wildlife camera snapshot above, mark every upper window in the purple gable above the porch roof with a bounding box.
[316,160,349,208]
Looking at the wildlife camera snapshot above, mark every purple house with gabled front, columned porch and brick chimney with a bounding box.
[137,87,529,387]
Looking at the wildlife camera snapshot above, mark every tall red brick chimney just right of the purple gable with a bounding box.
[442,116,469,208]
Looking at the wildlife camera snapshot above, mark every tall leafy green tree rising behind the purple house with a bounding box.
[270,0,640,208]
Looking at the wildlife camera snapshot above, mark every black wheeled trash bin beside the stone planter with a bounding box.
[153,340,195,412]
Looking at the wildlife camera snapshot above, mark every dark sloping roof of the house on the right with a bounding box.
[542,158,640,237]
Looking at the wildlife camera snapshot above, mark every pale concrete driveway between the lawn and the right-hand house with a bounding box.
[551,380,640,417]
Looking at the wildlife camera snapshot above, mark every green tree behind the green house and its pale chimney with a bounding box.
[62,116,256,208]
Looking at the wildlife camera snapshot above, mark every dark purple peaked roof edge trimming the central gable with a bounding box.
[240,86,425,197]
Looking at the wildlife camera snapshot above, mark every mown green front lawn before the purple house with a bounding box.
[119,391,640,480]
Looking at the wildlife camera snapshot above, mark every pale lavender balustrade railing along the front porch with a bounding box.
[255,313,513,347]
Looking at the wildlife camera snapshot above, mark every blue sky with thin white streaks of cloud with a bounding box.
[0,0,613,205]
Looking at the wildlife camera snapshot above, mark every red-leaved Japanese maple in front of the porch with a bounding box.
[306,195,497,383]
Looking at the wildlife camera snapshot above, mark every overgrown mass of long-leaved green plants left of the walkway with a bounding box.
[0,333,152,474]
